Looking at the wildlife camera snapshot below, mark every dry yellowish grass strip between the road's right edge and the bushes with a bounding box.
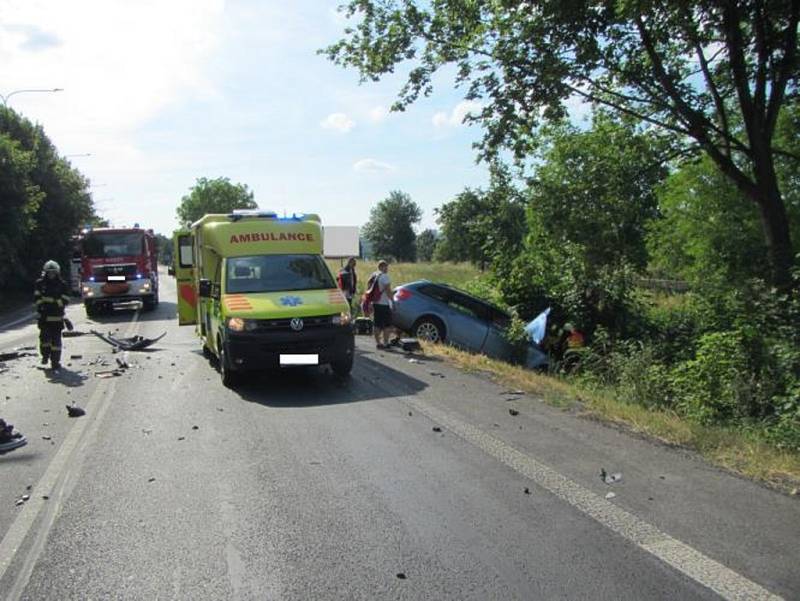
[424,344,800,495]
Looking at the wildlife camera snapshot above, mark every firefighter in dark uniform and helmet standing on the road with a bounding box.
[34,261,69,370]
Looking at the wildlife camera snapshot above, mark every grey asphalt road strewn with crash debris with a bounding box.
[0,277,800,600]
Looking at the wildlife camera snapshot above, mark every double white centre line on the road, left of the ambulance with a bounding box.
[0,312,139,600]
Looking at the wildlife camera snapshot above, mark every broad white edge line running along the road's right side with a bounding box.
[404,397,781,601]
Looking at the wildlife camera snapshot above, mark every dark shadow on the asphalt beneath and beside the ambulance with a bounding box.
[236,351,428,407]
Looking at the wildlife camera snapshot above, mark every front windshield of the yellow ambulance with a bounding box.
[225,255,336,294]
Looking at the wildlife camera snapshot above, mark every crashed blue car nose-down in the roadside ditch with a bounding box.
[392,280,547,367]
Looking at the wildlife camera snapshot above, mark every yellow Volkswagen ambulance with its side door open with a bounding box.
[173,211,355,387]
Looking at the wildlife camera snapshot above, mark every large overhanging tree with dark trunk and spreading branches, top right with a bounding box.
[322,0,800,286]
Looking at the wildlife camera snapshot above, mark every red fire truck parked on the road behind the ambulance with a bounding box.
[80,225,158,316]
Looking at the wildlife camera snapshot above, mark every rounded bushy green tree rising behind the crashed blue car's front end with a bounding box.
[528,112,667,269]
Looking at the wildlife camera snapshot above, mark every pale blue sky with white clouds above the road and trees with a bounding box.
[0,0,494,233]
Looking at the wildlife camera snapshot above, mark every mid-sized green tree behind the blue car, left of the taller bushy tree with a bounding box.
[436,164,525,270]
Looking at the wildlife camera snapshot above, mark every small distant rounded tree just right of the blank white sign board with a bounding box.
[363,190,422,261]
